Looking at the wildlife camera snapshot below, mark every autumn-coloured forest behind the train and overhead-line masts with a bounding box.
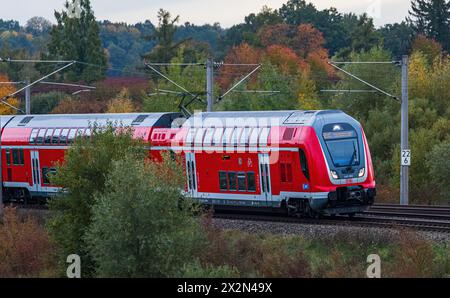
[0,0,450,204]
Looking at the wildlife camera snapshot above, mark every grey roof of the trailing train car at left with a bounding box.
[2,113,181,128]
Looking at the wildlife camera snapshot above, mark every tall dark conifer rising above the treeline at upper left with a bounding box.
[45,0,107,83]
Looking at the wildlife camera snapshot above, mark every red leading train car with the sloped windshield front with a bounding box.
[151,111,376,216]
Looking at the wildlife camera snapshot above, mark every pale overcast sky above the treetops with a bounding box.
[0,0,410,27]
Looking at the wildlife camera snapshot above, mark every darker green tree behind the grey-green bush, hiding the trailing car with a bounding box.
[47,123,145,277]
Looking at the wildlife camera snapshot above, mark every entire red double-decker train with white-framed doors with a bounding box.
[0,111,376,215]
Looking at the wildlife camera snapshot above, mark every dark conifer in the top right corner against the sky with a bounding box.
[408,0,450,51]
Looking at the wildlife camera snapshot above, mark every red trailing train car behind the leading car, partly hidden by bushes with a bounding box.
[1,113,180,201]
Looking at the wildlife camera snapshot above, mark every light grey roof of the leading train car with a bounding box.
[183,110,353,127]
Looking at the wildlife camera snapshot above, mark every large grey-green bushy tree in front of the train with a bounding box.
[86,156,206,278]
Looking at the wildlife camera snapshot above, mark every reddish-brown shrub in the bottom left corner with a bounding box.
[0,208,53,277]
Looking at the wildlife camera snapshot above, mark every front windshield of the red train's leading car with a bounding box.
[323,124,359,167]
